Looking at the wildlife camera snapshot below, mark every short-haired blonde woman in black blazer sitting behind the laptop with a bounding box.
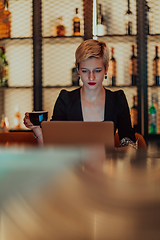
[24,39,137,149]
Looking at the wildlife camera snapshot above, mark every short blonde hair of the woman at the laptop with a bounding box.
[75,39,109,69]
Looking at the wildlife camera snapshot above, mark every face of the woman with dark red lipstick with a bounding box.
[78,57,107,89]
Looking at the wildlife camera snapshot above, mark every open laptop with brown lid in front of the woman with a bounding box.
[41,121,114,149]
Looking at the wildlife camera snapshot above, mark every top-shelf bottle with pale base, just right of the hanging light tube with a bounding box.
[97,4,107,36]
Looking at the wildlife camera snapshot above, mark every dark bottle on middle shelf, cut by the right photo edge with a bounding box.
[153,46,160,85]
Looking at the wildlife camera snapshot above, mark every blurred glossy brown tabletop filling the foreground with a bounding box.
[0,147,160,240]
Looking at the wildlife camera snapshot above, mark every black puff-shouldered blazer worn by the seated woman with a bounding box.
[51,88,136,142]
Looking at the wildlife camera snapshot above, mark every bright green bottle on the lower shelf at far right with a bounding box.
[149,96,157,134]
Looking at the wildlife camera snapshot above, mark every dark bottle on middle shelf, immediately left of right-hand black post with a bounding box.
[129,45,137,86]
